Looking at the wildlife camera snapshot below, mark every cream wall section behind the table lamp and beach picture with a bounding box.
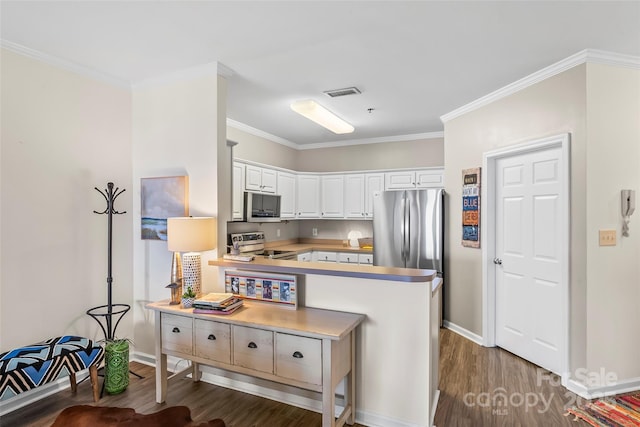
[133,69,225,354]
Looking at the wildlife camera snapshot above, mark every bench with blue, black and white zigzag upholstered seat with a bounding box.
[0,335,104,402]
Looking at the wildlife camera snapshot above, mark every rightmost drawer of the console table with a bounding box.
[276,333,322,385]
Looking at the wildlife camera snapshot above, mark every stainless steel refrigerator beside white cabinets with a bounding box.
[373,188,444,275]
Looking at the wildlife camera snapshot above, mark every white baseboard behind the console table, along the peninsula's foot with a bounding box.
[131,352,430,427]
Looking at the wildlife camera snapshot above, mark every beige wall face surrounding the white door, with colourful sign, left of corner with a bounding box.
[444,65,586,374]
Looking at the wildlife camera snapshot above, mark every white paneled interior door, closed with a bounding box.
[493,147,568,374]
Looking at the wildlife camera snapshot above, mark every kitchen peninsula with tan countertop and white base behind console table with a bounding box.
[209,257,442,426]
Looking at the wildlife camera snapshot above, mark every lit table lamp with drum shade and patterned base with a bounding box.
[167,216,217,296]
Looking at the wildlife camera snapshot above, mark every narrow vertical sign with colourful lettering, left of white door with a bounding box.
[462,168,481,248]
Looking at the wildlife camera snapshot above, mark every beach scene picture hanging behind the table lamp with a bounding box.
[140,176,189,240]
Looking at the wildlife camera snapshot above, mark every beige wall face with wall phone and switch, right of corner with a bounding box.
[585,64,640,381]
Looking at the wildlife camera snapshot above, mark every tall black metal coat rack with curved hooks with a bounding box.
[87,182,131,341]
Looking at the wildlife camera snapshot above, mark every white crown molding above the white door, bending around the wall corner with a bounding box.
[440,49,640,123]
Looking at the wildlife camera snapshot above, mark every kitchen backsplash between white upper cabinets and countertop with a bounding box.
[227,219,373,242]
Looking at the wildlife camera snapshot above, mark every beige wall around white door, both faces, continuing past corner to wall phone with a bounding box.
[445,64,640,383]
